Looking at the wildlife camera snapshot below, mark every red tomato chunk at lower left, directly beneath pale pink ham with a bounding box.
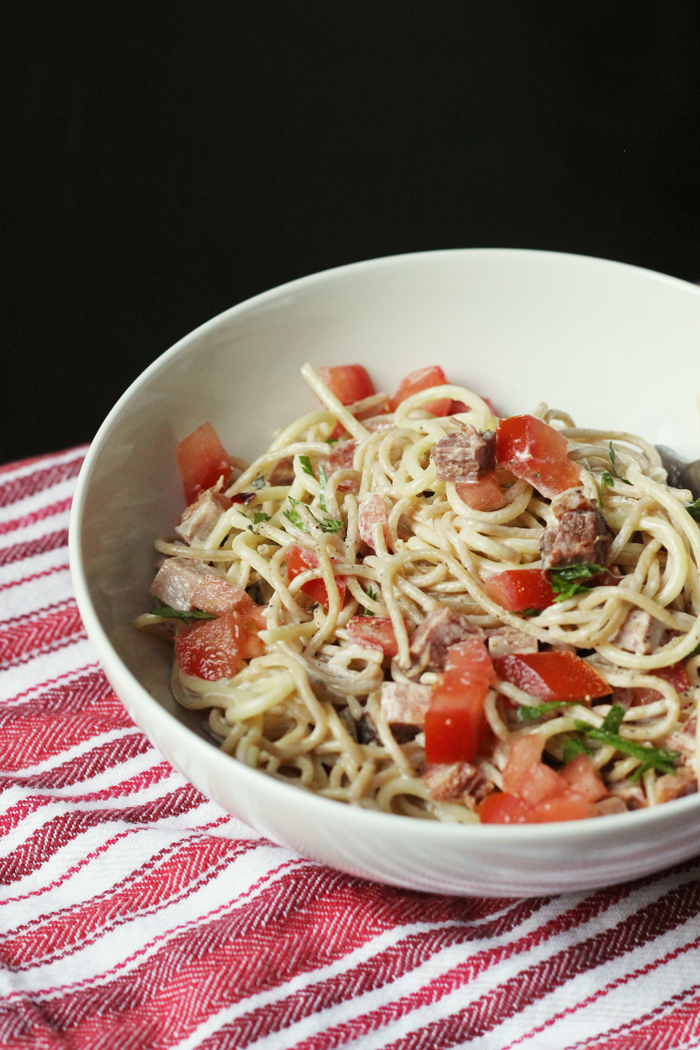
[175,603,264,681]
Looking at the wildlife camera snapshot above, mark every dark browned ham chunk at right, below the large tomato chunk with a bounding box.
[539,488,612,569]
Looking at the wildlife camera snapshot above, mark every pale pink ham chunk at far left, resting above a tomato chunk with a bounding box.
[151,558,252,614]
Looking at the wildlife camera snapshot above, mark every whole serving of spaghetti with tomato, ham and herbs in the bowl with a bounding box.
[136,364,700,824]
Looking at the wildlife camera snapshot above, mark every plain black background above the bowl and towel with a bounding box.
[0,0,700,462]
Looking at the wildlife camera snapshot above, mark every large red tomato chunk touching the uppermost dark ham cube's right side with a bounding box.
[496,416,580,499]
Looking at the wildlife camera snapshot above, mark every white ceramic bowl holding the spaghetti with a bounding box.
[70,250,700,896]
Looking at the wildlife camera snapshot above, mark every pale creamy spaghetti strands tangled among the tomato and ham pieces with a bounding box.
[136,365,700,823]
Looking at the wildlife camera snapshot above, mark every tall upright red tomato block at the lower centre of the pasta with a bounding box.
[425,636,495,764]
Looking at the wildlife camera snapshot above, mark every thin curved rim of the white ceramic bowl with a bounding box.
[68,248,700,847]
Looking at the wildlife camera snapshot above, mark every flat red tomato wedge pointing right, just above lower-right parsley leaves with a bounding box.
[494,652,611,700]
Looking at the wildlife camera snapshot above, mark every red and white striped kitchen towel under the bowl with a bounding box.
[0,448,700,1050]
